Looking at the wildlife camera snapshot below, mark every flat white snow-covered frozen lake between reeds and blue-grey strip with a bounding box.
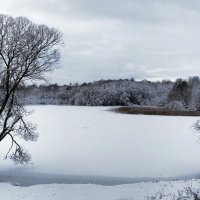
[0,106,200,183]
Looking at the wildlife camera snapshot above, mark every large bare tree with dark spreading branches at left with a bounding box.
[0,15,63,164]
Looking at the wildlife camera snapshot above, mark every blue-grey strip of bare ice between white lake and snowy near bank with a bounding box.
[0,170,200,187]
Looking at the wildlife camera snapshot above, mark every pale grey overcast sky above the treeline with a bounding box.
[0,0,200,84]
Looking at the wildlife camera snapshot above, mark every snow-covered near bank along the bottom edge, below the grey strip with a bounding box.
[0,180,200,200]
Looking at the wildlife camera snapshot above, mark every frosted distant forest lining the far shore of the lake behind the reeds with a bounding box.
[12,76,200,111]
